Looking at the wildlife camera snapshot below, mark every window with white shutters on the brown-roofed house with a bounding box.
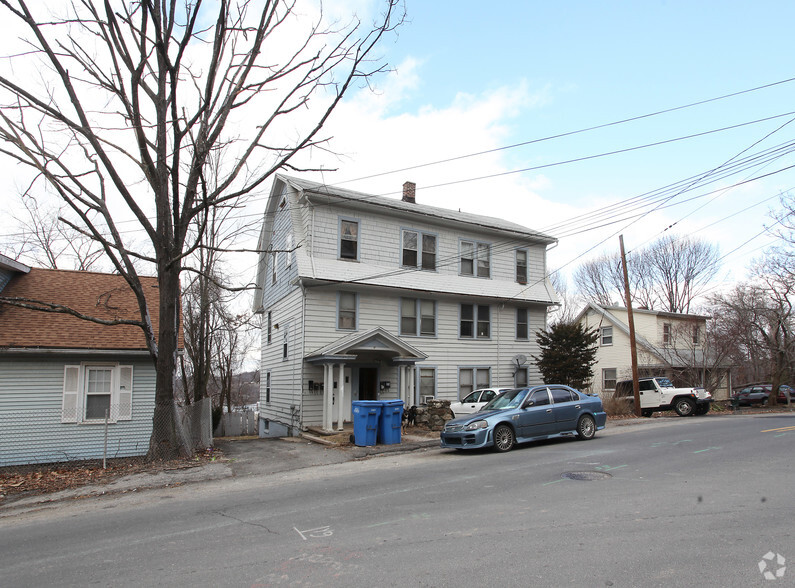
[61,364,133,423]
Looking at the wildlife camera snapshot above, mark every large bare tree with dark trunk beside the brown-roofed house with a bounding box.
[0,0,402,458]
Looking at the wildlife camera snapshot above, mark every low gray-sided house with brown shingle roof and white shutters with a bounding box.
[0,256,165,466]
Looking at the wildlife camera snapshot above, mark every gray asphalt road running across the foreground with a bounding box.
[0,413,795,587]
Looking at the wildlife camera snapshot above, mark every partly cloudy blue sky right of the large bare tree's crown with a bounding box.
[302,0,795,294]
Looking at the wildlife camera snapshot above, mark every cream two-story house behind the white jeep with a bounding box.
[575,302,731,400]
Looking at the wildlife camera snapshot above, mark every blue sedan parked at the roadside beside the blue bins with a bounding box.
[441,384,607,451]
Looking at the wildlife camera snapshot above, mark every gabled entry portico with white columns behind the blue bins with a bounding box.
[304,327,427,431]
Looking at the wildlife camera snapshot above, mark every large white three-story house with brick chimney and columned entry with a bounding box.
[254,175,556,436]
